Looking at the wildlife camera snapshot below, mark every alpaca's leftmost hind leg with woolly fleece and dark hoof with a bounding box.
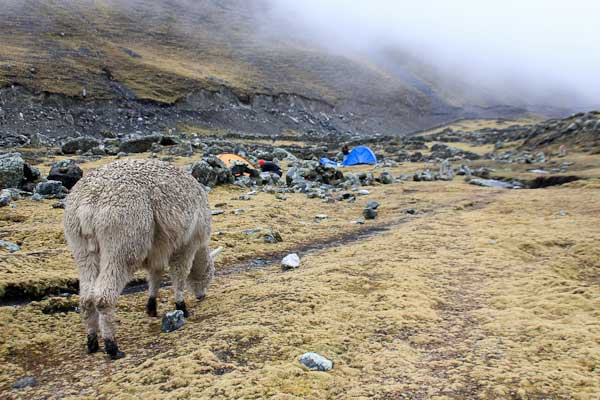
[75,246,100,353]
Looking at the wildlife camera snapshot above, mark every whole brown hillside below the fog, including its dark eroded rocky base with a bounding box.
[0,0,536,141]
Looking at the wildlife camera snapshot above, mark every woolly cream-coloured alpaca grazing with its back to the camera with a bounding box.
[64,160,219,359]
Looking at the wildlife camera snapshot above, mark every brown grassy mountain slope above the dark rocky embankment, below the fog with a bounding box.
[0,0,522,133]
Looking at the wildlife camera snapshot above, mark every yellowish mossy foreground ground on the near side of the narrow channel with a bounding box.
[0,183,600,399]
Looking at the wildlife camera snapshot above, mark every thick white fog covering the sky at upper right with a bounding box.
[268,0,600,106]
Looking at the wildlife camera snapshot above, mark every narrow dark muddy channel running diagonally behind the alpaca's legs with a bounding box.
[0,192,502,311]
